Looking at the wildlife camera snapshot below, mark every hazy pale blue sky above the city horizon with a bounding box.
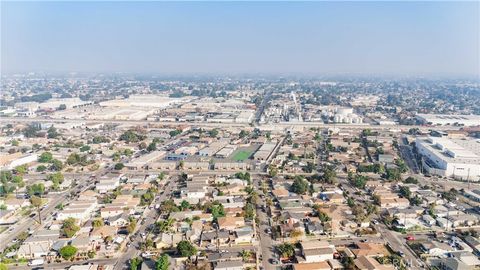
[1,1,480,76]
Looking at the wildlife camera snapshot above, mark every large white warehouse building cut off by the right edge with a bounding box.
[416,137,480,181]
